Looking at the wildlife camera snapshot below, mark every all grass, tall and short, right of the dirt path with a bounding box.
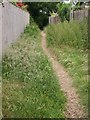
[46,21,88,114]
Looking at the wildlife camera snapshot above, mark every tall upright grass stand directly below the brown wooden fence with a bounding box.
[47,20,88,50]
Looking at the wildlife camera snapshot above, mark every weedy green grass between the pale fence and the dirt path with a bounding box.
[2,25,66,118]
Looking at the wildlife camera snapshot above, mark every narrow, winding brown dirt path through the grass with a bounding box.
[41,31,84,118]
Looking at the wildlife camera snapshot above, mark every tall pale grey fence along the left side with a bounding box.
[0,2,29,56]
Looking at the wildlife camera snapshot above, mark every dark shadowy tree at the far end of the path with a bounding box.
[26,2,57,29]
